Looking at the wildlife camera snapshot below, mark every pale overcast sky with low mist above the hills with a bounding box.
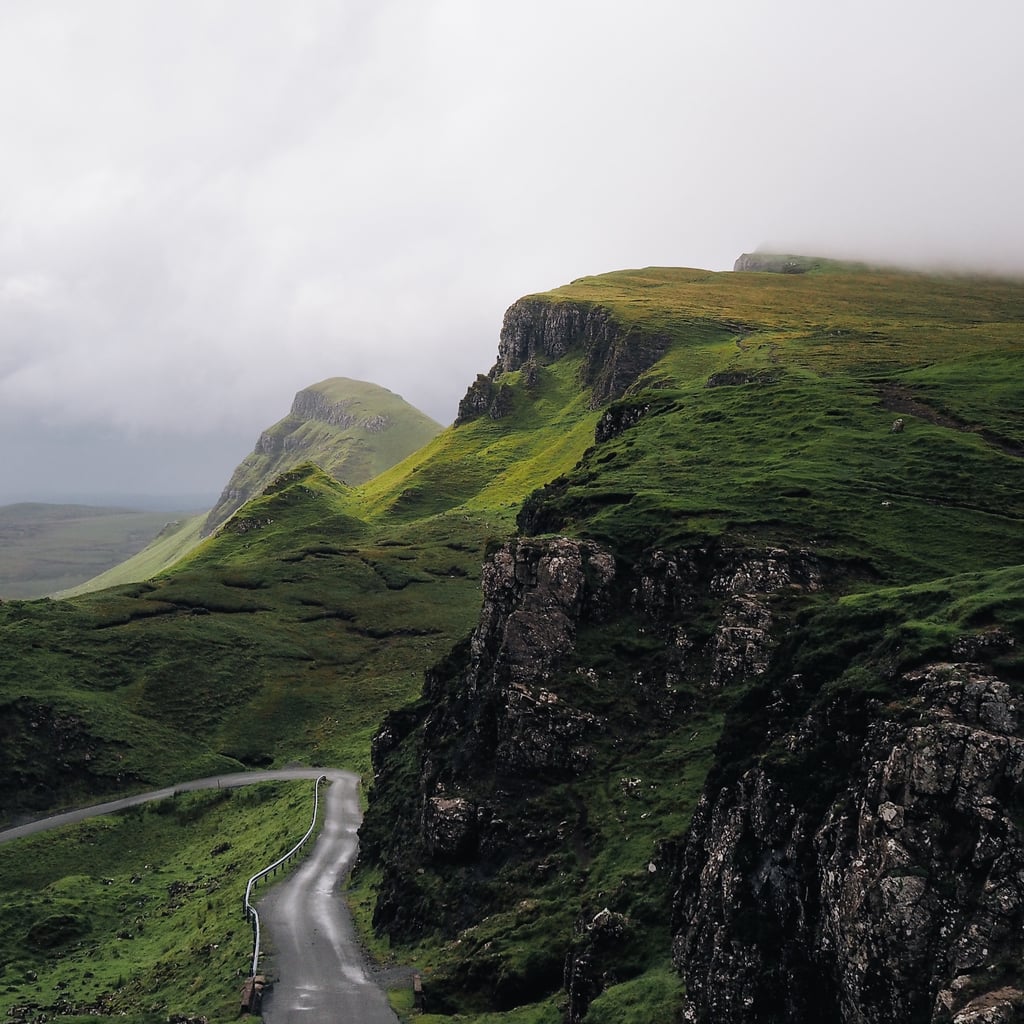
[0,0,1024,507]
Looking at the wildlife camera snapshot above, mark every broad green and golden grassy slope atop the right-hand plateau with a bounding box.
[528,269,1024,580]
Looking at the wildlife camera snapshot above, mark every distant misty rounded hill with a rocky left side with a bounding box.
[203,377,441,536]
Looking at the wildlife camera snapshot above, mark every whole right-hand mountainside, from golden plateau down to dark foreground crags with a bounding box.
[361,266,1024,1024]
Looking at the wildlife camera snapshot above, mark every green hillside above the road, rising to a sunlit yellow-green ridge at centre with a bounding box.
[0,354,596,1020]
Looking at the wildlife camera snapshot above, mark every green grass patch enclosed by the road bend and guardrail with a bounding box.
[0,782,312,1024]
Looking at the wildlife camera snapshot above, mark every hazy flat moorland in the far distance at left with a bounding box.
[0,502,199,599]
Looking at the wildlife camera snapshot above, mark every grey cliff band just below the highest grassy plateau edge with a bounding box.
[456,299,669,425]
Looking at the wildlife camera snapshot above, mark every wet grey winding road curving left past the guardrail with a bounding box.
[0,768,397,1024]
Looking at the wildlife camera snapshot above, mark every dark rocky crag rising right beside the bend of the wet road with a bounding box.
[361,538,822,1020]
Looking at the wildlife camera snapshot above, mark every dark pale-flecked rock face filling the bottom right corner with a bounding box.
[675,663,1024,1024]
